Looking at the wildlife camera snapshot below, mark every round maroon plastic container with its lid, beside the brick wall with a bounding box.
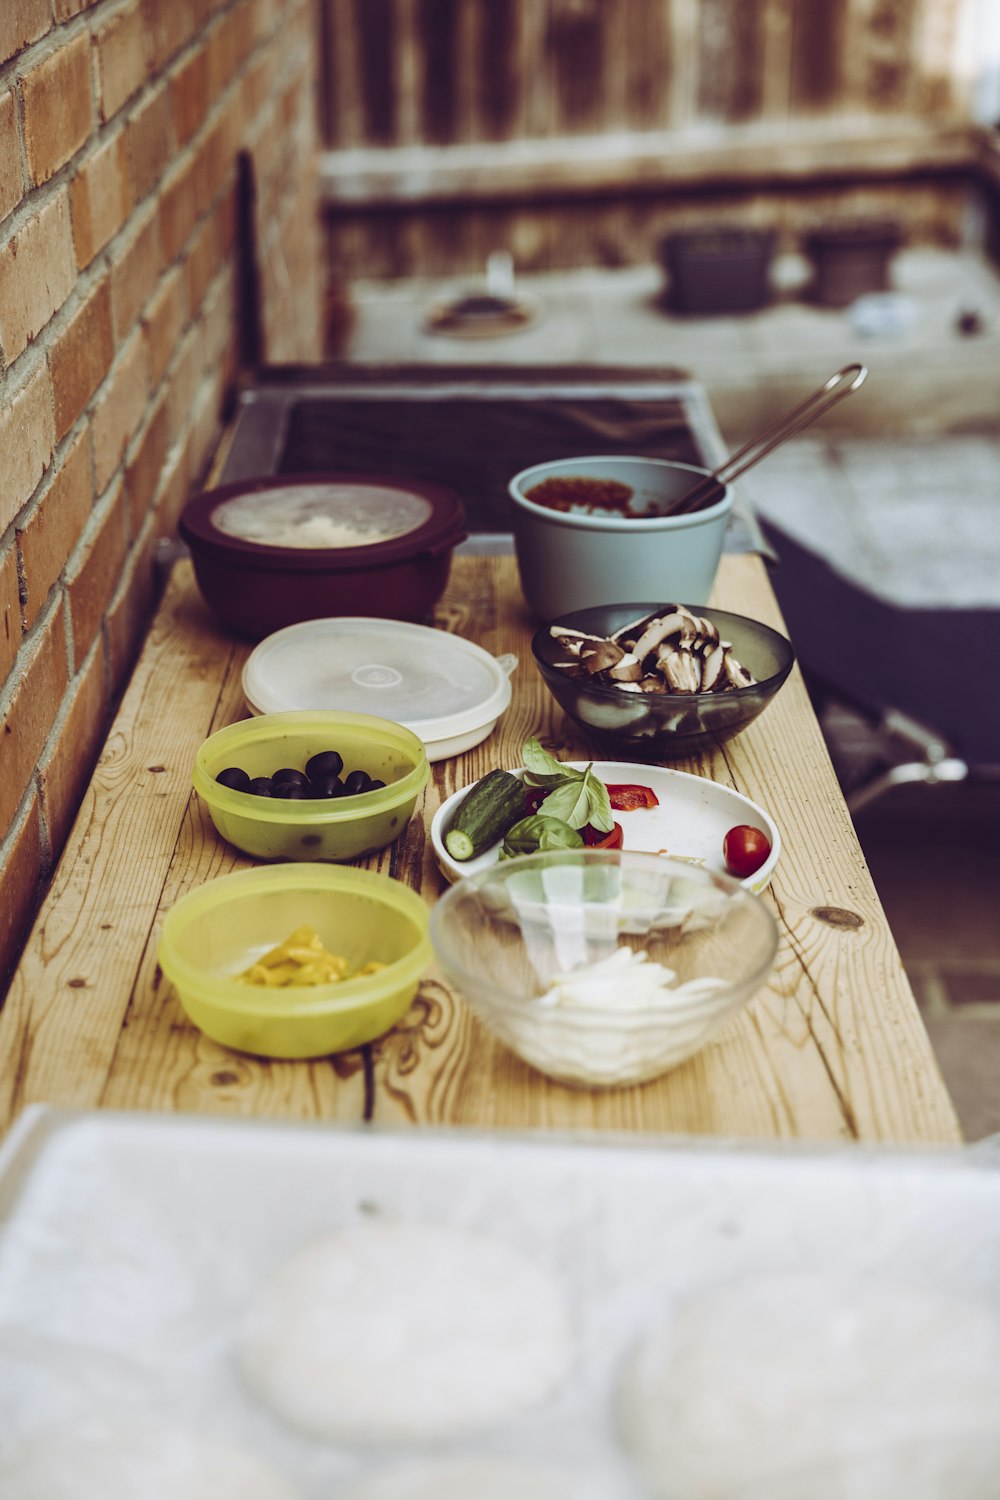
[180,474,468,641]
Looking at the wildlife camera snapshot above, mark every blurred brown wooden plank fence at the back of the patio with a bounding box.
[321,0,978,275]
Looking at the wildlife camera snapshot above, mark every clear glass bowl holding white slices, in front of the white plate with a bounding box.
[430,849,778,1088]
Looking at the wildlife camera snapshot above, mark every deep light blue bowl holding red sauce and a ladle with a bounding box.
[510,455,733,620]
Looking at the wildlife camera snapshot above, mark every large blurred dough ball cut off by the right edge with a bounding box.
[619,1274,1000,1500]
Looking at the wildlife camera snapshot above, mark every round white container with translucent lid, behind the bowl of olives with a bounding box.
[243,617,517,758]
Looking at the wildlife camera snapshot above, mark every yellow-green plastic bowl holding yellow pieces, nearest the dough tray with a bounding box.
[157,864,432,1058]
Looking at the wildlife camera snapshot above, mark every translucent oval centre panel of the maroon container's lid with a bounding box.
[211,480,433,548]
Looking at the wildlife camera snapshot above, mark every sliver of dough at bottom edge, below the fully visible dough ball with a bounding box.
[342,1457,625,1500]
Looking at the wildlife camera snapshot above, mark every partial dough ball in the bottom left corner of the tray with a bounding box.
[0,1416,297,1500]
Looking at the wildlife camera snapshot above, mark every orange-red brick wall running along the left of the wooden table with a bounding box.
[0,0,321,983]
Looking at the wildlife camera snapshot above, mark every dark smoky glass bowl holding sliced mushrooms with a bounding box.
[531,603,795,761]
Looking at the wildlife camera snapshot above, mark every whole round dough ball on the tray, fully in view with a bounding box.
[241,1221,573,1443]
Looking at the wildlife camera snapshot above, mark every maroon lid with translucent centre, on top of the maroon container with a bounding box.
[178,474,468,573]
